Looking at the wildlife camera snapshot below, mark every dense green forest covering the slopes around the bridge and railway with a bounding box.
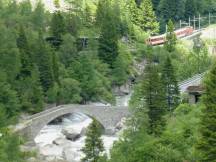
[0,0,216,162]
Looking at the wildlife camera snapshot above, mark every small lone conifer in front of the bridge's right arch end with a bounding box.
[82,120,104,162]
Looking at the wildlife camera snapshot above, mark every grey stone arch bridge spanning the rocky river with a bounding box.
[15,105,130,141]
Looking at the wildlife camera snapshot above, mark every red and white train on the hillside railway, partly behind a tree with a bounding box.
[147,27,194,46]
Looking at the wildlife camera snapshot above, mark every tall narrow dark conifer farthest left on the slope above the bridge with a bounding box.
[16,27,43,113]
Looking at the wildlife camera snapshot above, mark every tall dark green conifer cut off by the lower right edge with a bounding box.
[197,64,216,162]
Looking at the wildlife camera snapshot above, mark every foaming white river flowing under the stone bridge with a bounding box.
[35,94,131,162]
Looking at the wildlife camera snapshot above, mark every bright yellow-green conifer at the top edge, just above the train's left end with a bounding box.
[140,0,159,34]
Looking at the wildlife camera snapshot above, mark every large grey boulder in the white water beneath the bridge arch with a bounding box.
[62,126,81,141]
